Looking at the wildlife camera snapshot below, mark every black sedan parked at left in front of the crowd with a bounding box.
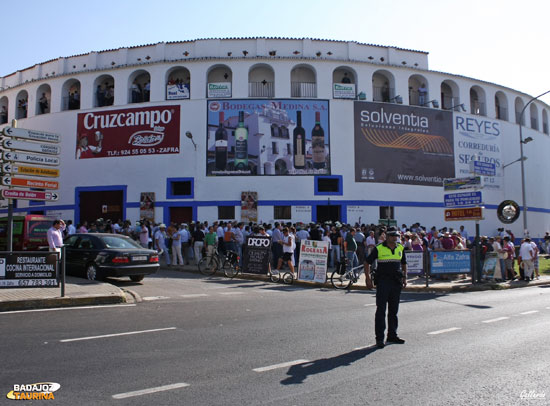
[65,233,160,282]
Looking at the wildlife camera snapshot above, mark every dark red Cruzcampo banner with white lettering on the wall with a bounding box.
[76,106,180,159]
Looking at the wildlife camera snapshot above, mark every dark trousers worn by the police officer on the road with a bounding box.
[374,279,401,341]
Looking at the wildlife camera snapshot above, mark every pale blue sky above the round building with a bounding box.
[4,0,550,104]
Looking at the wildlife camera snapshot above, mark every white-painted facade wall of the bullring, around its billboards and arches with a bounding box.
[0,38,550,237]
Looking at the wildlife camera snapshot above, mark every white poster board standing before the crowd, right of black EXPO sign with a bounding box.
[298,240,328,283]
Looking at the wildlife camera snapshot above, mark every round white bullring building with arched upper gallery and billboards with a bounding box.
[0,38,550,237]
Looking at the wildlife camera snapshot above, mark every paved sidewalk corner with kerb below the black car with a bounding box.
[0,276,128,312]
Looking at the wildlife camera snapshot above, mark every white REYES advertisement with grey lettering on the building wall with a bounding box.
[454,114,502,190]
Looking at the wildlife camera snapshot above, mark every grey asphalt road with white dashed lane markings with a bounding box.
[0,271,550,406]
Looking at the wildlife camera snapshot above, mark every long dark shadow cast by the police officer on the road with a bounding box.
[281,345,378,385]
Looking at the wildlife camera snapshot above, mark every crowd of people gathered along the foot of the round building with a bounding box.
[66,219,550,280]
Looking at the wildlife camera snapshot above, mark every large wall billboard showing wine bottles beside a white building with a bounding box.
[206,99,330,176]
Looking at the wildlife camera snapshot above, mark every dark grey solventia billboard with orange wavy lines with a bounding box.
[354,101,455,187]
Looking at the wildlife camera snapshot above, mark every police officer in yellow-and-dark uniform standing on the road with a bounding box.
[365,227,407,348]
